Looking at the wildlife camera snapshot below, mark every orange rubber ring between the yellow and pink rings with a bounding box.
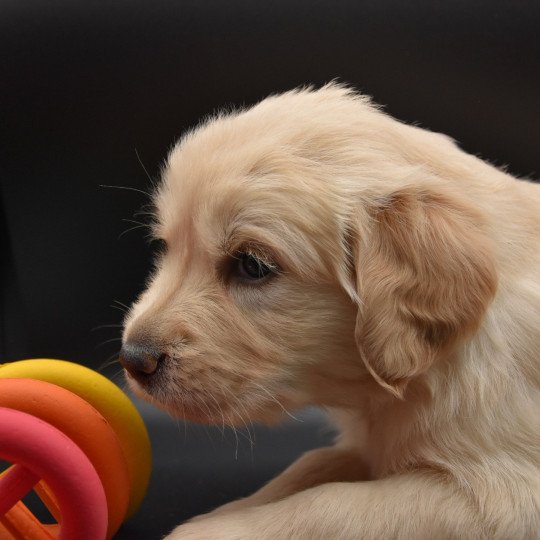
[0,379,130,538]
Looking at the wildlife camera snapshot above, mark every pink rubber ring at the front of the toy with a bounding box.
[0,407,107,540]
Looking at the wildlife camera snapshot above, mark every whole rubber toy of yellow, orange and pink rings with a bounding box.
[0,359,151,540]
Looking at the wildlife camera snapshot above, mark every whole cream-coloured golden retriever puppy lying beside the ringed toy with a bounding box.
[121,84,540,540]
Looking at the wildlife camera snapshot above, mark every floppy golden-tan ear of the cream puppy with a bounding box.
[353,188,497,396]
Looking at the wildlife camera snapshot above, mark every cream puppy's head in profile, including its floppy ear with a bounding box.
[121,87,494,424]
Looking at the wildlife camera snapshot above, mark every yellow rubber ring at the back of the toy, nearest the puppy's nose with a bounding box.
[0,358,152,519]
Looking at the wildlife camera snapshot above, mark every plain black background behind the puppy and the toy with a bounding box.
[0,0,540,540]
